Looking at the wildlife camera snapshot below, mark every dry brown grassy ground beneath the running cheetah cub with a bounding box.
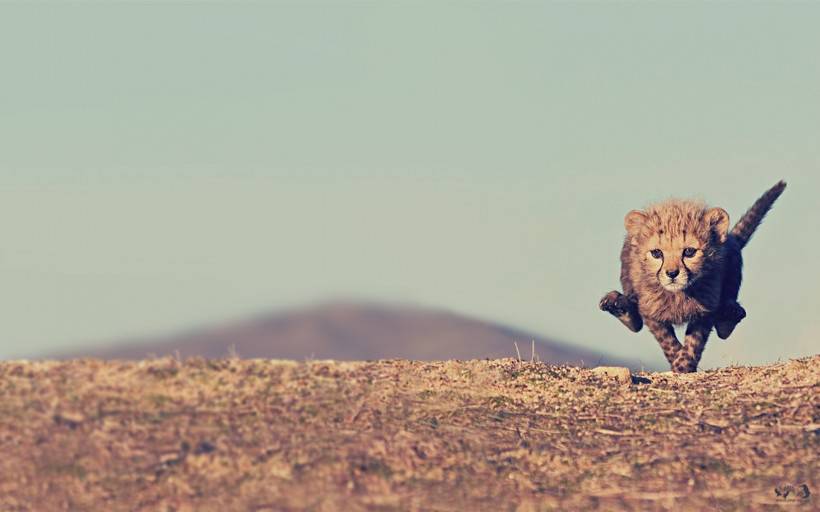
[0,356,820,512]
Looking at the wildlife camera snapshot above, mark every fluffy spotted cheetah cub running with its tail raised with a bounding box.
[599,181,786,373]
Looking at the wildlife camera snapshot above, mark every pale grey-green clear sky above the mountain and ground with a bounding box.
[0,2,820,368]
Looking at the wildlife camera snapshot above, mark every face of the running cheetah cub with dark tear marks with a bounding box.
[624,203,729,293]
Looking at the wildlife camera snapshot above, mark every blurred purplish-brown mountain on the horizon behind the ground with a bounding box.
[60,303,640,368]
